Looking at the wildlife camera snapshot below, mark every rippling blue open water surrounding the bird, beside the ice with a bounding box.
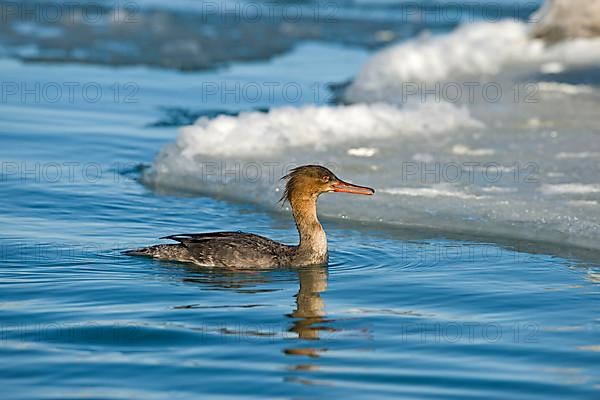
[0,2,600,399]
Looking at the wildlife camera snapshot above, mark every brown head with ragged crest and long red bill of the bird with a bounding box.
[281,165,375,203]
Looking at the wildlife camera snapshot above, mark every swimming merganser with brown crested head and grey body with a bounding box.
[124,165,375,268]
